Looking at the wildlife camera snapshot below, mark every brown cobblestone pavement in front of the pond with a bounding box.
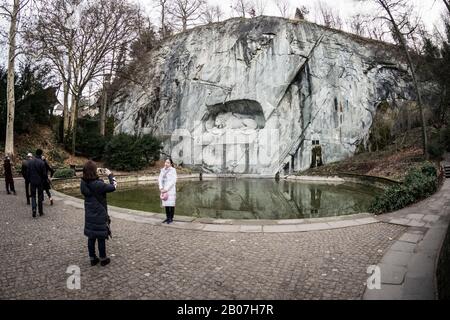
[0,180,406,299]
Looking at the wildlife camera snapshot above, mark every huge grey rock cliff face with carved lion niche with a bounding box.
[110,17,414,175]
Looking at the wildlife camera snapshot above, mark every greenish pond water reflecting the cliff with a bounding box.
[62,179,381,219]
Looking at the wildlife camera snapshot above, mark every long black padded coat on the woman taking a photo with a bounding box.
[80,175,116,239]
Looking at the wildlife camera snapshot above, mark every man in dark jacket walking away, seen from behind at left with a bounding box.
[27,149,47,218]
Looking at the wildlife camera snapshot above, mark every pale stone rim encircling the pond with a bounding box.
[49,174,390,233]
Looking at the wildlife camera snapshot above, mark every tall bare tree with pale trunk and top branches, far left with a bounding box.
[0,0,29,157]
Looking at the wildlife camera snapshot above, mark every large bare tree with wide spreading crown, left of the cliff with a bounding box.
[28,0,140,153]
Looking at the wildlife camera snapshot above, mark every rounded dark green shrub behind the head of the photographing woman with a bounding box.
[103,133,147,171]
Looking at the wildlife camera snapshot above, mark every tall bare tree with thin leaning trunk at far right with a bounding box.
[373,0,428,158]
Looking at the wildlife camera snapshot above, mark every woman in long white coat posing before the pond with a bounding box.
[158,158,177,224]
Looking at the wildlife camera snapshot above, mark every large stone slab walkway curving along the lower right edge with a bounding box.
[364,180,450,300]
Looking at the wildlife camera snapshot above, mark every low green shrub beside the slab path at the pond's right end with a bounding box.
[369,163,438,214]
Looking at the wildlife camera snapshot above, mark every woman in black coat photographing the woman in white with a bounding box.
[80,160,117,266]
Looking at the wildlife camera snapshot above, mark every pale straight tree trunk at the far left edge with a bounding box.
[5,0,19,157]
